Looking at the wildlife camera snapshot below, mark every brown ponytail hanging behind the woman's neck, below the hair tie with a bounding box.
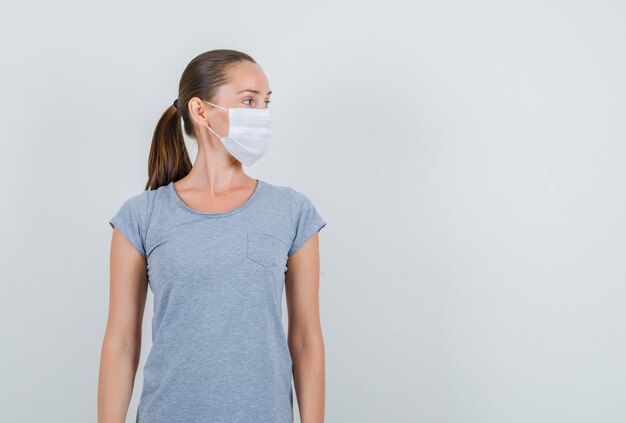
[145,105,191,190]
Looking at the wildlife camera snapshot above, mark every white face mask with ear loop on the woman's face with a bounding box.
[205,101,272,166]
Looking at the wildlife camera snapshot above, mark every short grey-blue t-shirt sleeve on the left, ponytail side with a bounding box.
[109,191,148,258]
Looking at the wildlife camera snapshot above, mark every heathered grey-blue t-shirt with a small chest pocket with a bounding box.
[109,180,326,423]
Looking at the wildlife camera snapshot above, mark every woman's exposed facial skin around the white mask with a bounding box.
[203,61,272,136]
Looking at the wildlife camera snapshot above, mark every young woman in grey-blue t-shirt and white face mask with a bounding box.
[98,50,326,423]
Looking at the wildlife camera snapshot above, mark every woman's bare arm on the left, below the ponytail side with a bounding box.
[98,228,148,423]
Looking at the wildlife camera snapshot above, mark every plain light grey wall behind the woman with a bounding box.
[0,0,626,423]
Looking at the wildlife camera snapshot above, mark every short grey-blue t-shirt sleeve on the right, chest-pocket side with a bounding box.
[289,188,326,255]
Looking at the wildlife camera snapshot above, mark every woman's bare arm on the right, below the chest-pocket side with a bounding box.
[285,232,325,423]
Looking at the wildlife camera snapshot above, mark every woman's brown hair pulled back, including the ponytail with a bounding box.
[145,49,256,190]
